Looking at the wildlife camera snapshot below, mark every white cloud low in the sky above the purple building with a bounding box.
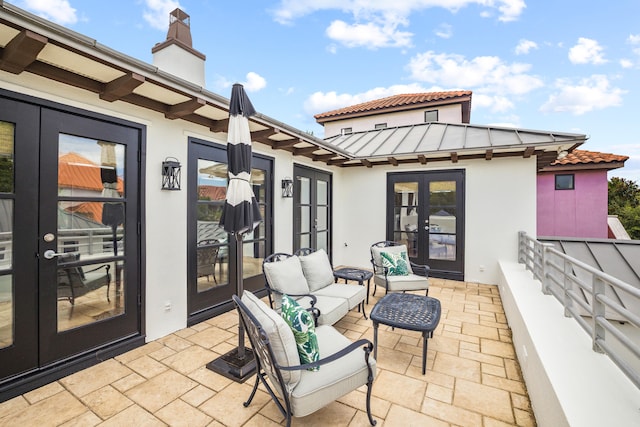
[540,74,627,116]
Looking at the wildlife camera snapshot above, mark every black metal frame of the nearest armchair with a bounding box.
[232,294,376,427]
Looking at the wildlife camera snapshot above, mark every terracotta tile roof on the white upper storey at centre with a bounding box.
[313,90,472,120]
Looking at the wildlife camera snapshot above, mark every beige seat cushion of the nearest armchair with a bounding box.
[291,325,376,417]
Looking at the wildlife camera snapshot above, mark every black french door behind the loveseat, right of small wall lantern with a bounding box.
[293,165,332,257]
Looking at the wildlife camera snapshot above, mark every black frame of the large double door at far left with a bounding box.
[0,89,146,401]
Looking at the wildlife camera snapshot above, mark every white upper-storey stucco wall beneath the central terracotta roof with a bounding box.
[324,104,462,137]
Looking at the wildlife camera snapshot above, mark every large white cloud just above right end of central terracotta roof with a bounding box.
[408,51,544,112]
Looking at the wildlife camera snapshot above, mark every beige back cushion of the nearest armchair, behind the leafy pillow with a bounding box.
[242,291,300,388]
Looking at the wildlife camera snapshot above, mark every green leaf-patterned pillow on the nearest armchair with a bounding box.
[281,295,320,371]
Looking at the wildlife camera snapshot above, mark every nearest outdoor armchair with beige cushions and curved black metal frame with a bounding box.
[233,291,376,427]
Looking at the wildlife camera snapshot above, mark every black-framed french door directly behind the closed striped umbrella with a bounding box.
[187,138,273,324]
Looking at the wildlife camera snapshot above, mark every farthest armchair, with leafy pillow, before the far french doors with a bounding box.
[371,240,429,295]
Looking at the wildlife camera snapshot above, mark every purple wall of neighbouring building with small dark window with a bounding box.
[537,170,608,239]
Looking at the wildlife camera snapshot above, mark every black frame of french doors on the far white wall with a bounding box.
[386,169,466,281]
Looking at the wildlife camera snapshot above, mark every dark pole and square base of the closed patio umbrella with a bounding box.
[207,234,256,383]
